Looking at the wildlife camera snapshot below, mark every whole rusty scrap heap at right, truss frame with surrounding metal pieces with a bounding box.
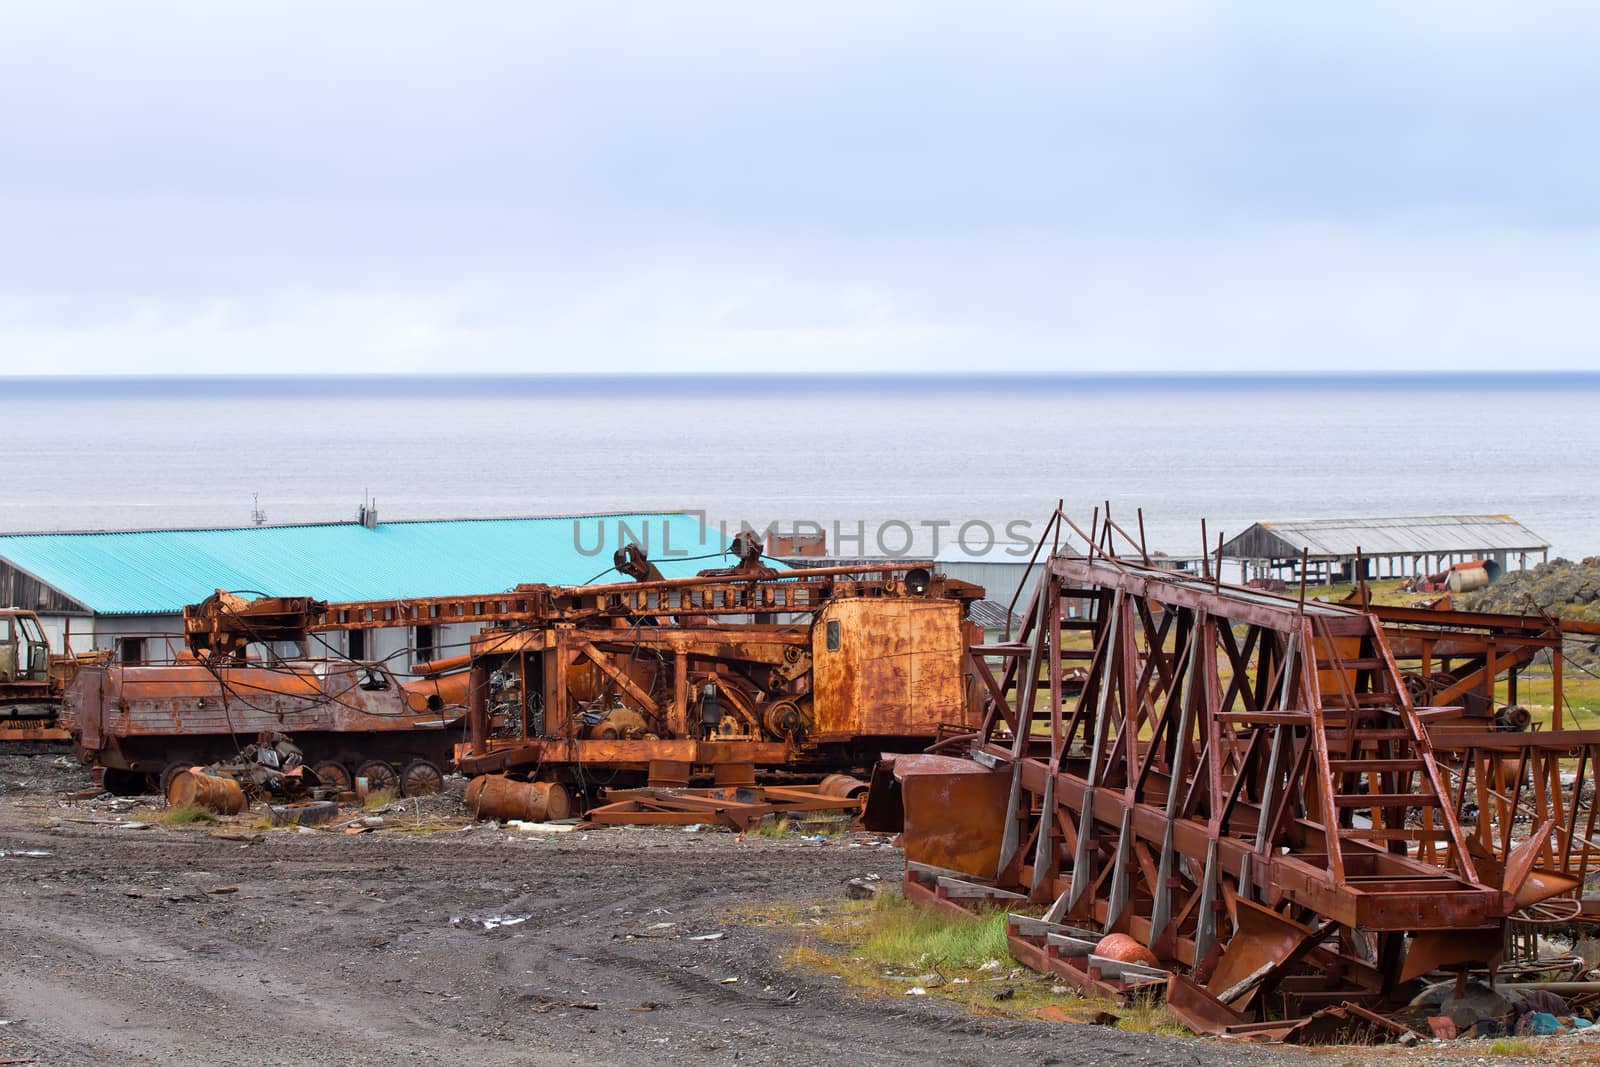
[867,517,1600,1035]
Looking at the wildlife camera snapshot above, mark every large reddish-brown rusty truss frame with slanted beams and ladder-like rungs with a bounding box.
[906,520,1522,1011]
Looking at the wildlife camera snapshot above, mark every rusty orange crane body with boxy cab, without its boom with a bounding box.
[459,582,973,785]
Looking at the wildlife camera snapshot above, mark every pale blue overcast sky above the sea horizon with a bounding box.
[0,0,1600,374]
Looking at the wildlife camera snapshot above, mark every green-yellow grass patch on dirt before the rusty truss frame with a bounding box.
[752,894,1187,1033]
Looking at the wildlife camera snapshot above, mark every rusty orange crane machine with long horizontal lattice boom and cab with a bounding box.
[162,559,982,803]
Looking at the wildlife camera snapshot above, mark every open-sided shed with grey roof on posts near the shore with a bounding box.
[1222,515,1550,584]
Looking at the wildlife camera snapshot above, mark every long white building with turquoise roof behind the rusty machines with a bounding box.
[0,512,726,673]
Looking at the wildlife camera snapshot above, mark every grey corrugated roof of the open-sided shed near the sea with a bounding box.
[1222,515,1550,560]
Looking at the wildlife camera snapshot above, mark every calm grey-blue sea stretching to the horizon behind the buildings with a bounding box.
[0,376,1600,557]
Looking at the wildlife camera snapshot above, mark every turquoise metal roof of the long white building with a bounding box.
[0,512,733,614]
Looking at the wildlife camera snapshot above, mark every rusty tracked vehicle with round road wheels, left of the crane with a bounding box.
[62,593,462,795]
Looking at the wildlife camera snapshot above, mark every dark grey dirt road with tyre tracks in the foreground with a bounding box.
[0,757,1273,1067]
